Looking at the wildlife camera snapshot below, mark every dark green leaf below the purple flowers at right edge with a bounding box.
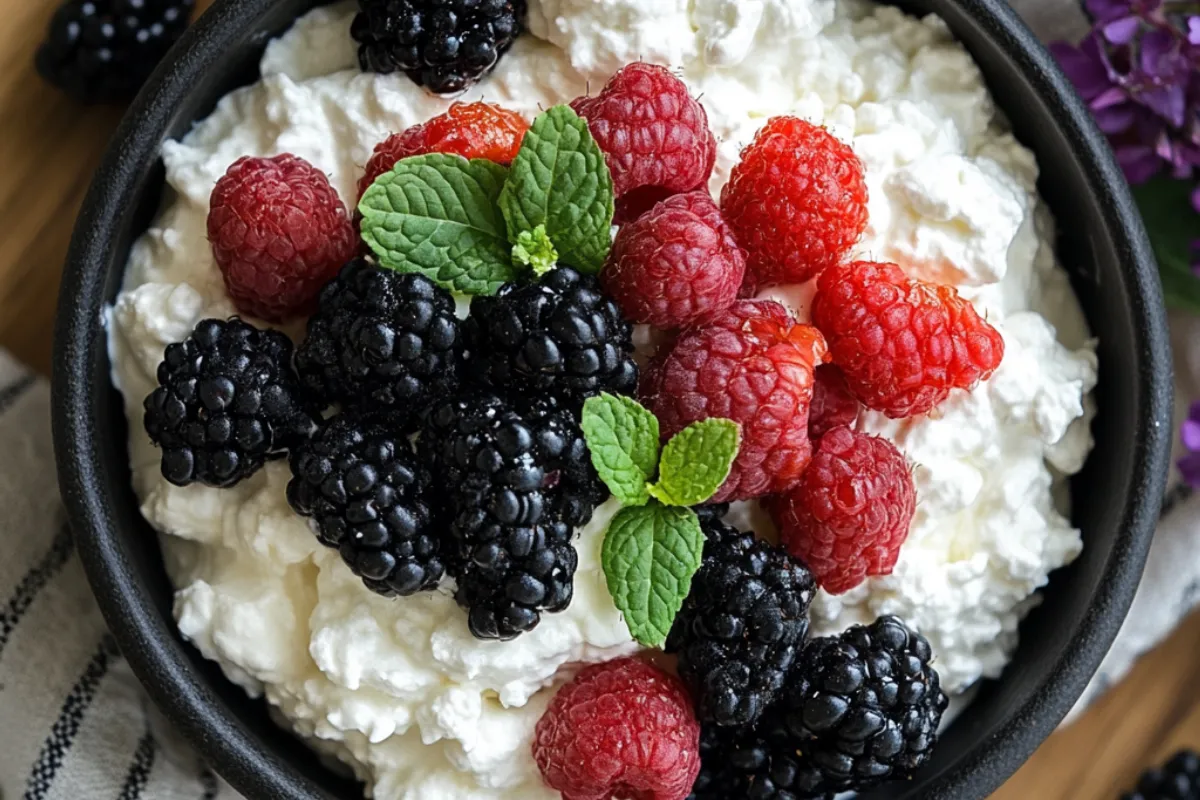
[1133,176,1200,314]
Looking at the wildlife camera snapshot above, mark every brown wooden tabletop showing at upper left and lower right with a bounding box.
[0,0,1200,800]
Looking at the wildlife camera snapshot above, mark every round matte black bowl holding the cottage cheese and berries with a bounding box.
[54,0,1171,800]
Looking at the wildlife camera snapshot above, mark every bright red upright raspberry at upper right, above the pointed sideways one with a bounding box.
[721,116,866,287]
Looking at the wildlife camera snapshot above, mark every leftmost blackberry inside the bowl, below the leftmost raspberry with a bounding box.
[144,317,316,487]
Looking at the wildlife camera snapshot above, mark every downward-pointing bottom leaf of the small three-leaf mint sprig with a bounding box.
[600,503,704,648]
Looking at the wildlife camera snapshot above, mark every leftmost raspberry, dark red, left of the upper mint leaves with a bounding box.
[209,154,358,323]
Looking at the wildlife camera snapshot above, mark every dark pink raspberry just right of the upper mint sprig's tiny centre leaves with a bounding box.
[600,192,745,329]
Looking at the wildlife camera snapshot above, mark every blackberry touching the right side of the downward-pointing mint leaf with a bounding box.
[666,516,816,728]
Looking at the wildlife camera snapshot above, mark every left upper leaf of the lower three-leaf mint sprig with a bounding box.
[580,395,659,506]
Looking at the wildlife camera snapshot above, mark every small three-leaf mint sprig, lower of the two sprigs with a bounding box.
[581,395,742,646]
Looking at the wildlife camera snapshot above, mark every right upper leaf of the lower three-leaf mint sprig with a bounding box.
[649,419,742,506]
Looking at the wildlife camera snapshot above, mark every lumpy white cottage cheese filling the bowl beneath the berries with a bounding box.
[110,0,1096,800]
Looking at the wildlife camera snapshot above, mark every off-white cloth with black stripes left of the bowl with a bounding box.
[0,351,240,800]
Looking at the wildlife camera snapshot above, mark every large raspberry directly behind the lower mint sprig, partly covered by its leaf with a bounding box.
[642,300,824,503]
